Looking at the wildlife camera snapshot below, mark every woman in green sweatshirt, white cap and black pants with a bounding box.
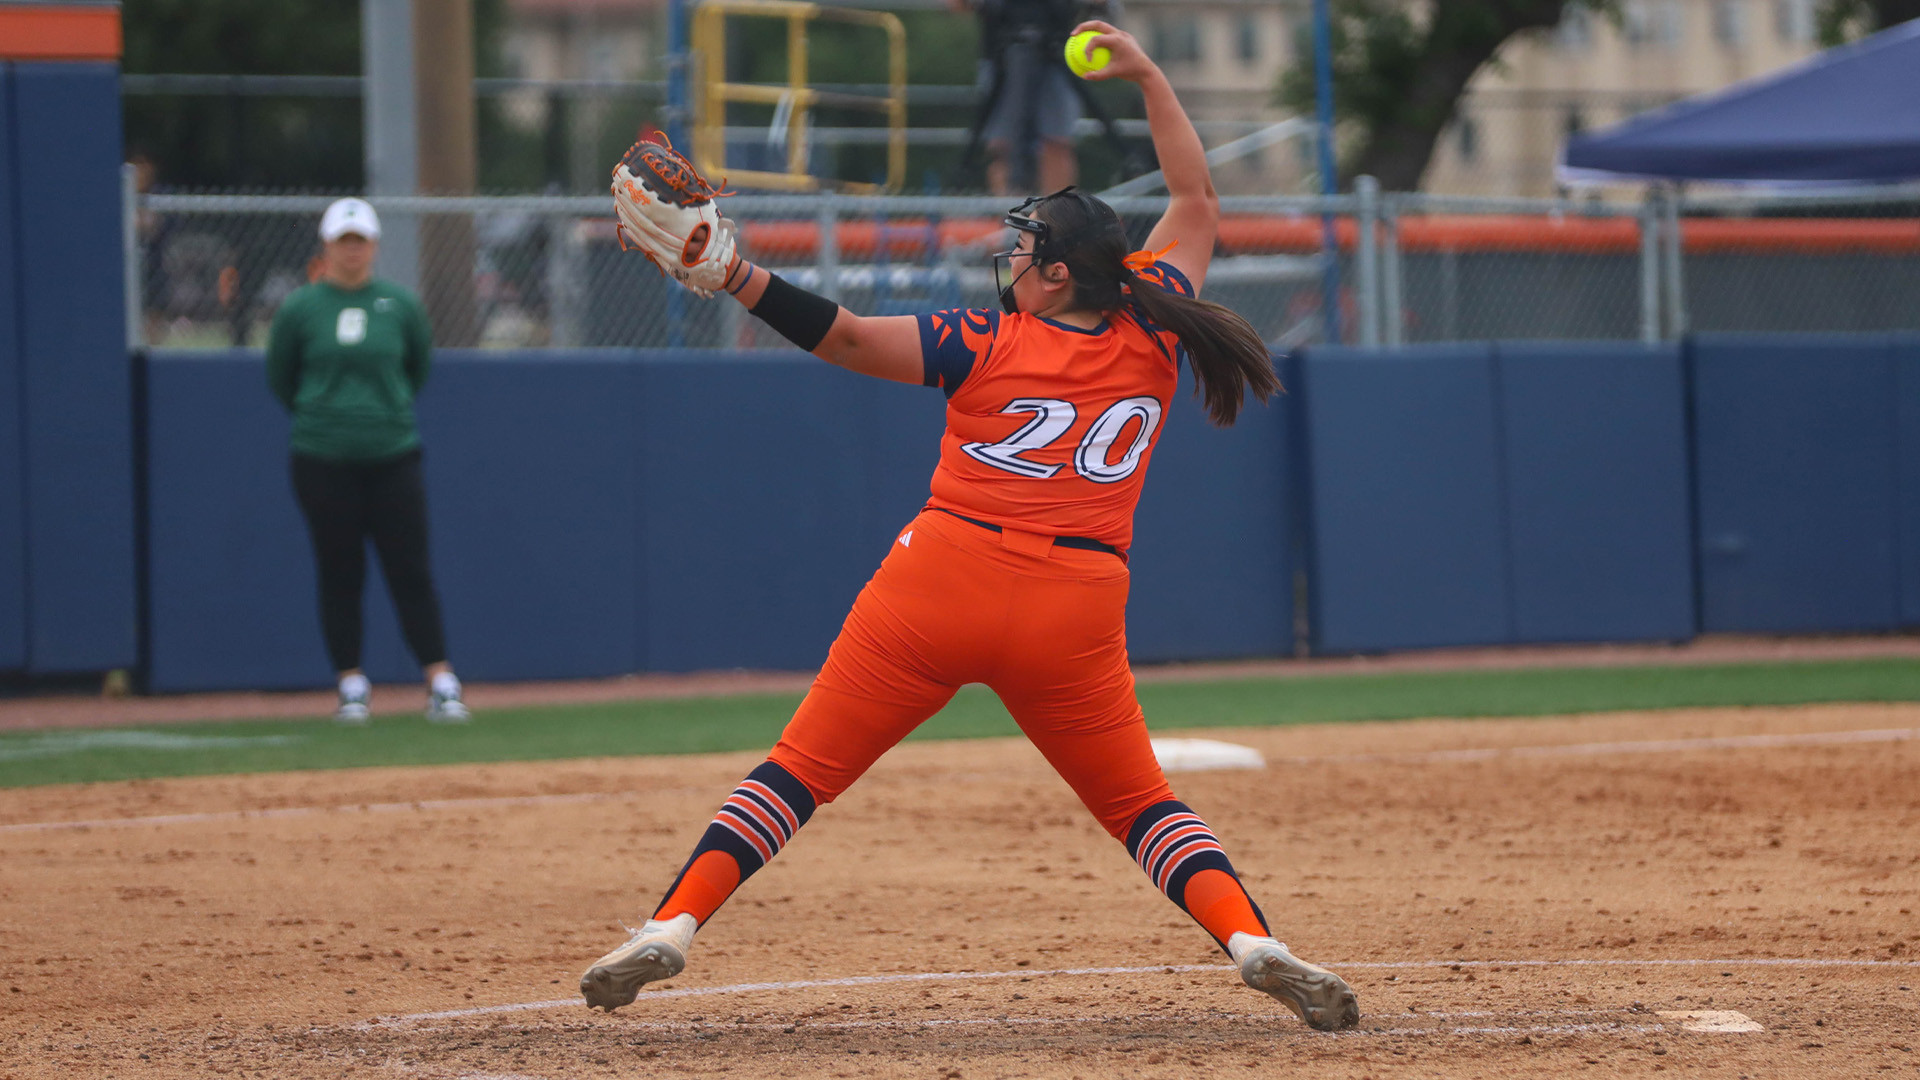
[267,198,468,724]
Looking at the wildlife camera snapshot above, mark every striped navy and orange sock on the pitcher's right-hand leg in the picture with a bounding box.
[1127,799,1271,949]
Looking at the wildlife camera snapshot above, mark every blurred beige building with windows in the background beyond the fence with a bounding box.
[487,0,1818,196]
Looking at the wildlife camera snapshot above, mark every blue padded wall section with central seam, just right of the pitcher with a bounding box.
[1298,342,1693,653]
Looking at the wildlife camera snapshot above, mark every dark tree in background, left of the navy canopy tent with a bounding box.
[1279,0,1612,190]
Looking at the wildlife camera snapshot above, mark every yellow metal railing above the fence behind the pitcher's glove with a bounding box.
[693,0,906,194]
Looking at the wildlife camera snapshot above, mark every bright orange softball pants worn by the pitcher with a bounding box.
[770,509,1173,840]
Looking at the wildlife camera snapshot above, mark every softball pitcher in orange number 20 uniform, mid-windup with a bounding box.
[580,21,1359,1030]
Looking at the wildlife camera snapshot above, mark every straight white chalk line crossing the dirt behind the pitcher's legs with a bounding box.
[0,728,1920,834]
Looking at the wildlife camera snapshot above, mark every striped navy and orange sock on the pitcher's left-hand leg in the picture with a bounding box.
[653,761,814,924]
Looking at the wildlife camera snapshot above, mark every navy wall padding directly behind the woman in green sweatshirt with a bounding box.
[148,352,641,687]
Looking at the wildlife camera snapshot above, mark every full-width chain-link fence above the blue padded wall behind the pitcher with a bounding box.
[129,179,1920,348]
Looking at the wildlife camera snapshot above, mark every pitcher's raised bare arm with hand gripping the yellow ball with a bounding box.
[1073,19,1219,292]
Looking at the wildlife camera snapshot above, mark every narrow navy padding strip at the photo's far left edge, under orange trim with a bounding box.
[0,63,27,671]
